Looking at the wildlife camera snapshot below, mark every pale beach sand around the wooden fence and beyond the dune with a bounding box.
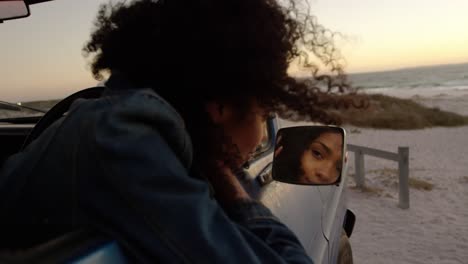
[345,89,468,264]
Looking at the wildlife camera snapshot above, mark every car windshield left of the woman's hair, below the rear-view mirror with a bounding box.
[0,0,109,118]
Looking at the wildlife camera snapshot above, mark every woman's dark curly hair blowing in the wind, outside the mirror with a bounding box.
[83,0,370,177]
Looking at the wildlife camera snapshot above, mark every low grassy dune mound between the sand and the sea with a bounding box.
[339,94,468,130]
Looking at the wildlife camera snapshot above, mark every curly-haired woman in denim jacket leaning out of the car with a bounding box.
[0,0,364,263]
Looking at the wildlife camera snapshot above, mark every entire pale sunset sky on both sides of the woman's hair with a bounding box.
[0,0,468,101]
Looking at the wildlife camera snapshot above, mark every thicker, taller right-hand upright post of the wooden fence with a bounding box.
[398,147,409,209]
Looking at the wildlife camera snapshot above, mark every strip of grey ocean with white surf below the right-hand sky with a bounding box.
[349,63,468,92]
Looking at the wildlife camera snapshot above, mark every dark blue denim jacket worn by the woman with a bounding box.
[0,76,312,263]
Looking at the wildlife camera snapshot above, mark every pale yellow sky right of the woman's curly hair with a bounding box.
[311,0,468,72]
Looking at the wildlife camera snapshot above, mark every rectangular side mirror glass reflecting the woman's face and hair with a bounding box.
[272,126,346,185]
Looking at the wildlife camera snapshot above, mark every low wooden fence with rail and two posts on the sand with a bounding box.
[347,144,409,209]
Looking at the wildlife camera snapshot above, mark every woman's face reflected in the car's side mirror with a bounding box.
[299,131,343,184]
